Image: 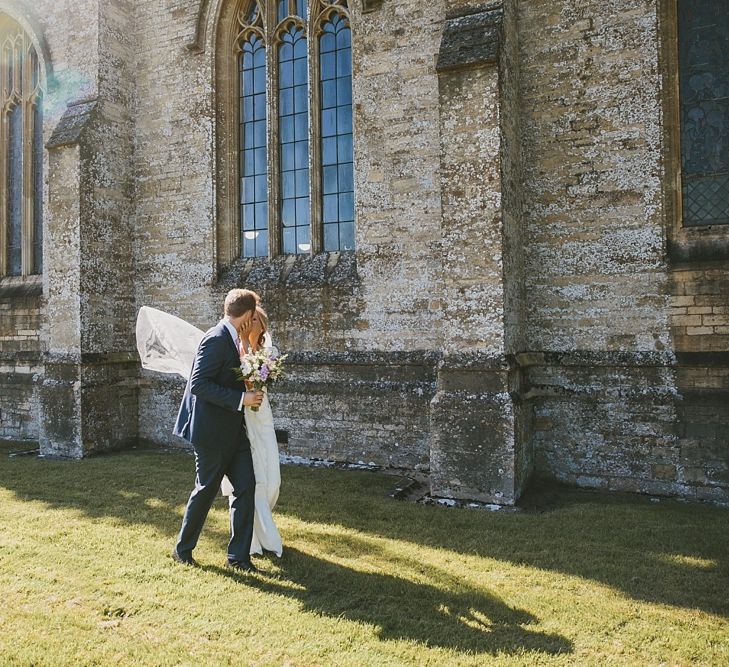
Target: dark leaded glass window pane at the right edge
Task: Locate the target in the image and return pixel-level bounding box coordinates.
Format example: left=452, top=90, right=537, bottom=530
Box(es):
left=677, top=0, right=729, bottom=226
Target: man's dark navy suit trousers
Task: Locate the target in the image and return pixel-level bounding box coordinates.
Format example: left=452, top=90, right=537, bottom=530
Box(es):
left=176, top=433, right=256, bottom=561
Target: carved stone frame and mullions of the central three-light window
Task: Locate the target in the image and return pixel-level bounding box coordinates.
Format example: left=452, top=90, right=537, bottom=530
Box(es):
left=214, top=0, right=354, bottom=269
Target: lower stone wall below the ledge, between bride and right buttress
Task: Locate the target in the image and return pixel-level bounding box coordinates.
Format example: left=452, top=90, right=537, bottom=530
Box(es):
left=271, top=352, right=437, bottom=470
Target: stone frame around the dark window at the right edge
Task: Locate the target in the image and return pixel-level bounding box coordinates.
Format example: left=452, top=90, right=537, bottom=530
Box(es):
left=658, top=0, right=729, bottom=262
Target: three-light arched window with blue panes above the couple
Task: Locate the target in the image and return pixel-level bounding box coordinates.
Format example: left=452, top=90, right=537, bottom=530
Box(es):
left=234, top=0, right=354, bottom=257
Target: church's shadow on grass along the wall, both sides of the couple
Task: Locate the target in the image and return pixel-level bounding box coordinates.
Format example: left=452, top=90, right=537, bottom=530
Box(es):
left=0, top=448, right=729, bottom=624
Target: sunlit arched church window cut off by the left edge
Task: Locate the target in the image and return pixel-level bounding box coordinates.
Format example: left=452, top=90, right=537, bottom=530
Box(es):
left=0, top=14, right=43, bottom=276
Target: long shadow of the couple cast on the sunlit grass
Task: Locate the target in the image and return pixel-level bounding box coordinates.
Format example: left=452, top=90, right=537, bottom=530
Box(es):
left=204, top=543, right=572, bottom=655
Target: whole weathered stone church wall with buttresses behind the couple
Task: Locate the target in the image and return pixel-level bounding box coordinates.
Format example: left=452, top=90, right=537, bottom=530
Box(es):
left=0, top=0, right=729, bottom=502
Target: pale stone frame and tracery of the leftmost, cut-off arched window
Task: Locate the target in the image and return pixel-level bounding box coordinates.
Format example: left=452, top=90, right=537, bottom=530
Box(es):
left=0, top=12, right=47, bottom=284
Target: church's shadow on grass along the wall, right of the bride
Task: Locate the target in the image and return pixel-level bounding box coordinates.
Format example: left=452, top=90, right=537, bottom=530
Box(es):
left=277, top=470, right=729, bottom=617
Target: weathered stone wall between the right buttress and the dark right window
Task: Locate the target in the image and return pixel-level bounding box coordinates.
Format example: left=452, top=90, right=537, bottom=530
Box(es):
left=519, top=0, right=676, bottom=492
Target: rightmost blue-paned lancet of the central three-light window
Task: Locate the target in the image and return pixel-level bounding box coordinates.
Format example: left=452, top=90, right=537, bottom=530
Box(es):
left=319, top=14, right=354, bottom=250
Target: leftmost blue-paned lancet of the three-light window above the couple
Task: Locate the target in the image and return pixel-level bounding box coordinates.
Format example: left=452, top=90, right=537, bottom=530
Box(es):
left=239, top=34, right=268, bottom=257
